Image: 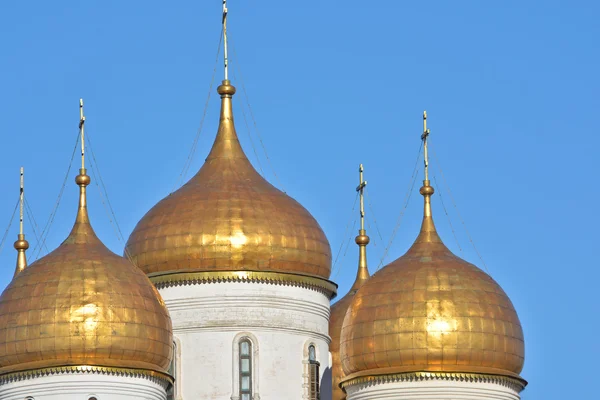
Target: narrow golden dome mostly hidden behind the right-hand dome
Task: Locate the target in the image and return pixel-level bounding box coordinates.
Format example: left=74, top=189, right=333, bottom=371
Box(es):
left=329, top=229, right=369, bottom=400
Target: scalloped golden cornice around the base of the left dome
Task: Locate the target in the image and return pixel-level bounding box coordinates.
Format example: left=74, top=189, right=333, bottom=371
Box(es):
left=0, top=365, right=173, bottom=389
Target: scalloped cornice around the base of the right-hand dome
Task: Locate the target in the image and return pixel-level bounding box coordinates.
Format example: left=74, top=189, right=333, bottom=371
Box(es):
left=340, top=372, right=527, bottom=393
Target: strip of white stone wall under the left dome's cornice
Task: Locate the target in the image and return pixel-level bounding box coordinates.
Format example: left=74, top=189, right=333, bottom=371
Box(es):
left=0, top=372, right=167, bottom=400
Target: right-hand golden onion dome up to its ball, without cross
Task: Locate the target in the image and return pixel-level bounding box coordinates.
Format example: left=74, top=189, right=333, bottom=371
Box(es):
left=341, top=180, right=525, bottom=379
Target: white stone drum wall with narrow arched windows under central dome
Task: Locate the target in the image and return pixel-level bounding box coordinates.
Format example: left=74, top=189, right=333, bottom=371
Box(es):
left=159, top=282, right=331, bottom=400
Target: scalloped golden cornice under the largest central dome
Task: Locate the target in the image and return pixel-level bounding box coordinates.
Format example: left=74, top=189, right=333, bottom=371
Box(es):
left=148, top=271, right=337, bottom=299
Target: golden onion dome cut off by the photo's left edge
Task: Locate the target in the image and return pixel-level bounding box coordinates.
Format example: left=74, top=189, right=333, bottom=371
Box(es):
left=0, top=169, right=172, bottom=374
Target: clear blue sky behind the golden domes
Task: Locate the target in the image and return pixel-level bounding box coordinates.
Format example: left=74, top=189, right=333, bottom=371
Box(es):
left=0, top=0, right=600, bottom=400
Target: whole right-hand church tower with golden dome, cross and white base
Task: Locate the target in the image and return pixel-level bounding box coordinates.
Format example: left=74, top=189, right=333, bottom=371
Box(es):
left=340, top=114, right=527, bottom=400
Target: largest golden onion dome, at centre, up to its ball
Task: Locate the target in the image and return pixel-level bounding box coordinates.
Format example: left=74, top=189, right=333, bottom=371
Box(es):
left=125, top=80, right=331, bottom=279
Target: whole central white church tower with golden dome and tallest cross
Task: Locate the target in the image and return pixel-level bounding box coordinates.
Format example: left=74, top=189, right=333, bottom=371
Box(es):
left=125, top=1, right=336, bottom=400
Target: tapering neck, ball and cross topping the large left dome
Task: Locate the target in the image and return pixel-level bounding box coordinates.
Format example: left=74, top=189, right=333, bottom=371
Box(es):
left=65, top=99, right=98, bottom=243
